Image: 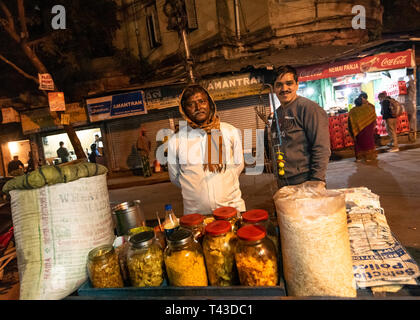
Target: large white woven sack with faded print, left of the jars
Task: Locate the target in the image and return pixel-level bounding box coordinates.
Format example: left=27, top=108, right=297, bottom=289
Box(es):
left=10, top=175, right=115, bottom=300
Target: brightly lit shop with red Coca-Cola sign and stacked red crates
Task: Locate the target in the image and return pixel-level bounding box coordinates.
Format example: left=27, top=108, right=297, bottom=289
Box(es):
left=298, top=49, right=416, bottom=150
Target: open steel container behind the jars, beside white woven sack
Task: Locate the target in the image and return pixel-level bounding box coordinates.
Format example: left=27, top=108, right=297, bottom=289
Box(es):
left=112, top=200, right=146, bottom=236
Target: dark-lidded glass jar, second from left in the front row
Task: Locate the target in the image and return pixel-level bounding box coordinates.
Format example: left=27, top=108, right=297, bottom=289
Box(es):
left=127, top=231, right=164, bottom=287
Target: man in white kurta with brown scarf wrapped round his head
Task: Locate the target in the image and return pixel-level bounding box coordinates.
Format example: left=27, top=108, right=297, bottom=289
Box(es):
left=168, top=85, right=245, bottom=214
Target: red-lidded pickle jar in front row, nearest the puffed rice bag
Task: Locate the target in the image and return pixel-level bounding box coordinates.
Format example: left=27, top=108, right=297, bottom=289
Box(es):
left=235, top=225, right=278, bottom=286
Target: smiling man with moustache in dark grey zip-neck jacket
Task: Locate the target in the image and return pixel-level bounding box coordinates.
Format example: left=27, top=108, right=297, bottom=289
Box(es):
left=272, top=66, right=331, bottom=188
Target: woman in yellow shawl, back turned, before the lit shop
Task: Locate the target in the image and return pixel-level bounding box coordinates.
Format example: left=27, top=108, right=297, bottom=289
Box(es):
left=348, top=97, right=376, bottom=162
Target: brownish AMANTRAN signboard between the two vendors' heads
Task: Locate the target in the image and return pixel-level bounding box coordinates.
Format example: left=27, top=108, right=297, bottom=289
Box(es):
left=200, top=73, right=268, bottom=100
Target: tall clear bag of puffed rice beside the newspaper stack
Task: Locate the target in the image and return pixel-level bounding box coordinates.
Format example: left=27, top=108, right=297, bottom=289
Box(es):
left=274, top=182, right=356, bottom=297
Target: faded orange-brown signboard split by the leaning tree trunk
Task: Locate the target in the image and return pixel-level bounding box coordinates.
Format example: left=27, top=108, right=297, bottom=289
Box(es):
left=21, top=103, right=88, bottom=134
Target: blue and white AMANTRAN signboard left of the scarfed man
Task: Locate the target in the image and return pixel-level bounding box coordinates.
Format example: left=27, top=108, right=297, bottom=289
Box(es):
left=86, top=91, right=147, bottom=122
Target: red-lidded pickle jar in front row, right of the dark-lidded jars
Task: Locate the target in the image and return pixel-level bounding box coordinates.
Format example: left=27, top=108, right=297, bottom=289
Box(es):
left=203, top=220, right=238, bottom=286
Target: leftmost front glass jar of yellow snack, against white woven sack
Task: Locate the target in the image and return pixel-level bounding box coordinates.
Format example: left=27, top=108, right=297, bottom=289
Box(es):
left=87, top=245, right=124, bottom=288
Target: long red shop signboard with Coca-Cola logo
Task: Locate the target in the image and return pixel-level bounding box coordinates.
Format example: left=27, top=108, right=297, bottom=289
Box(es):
left=297, top=50, right=415, bottom=82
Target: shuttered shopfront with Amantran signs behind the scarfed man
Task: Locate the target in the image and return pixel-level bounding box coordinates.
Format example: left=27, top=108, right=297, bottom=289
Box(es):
left=86, top=74, right=270, bottom=172
